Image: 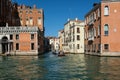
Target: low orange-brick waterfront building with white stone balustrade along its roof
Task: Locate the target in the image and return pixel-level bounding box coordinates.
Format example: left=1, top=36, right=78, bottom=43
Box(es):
left=0, top=27, right=40, bottom=55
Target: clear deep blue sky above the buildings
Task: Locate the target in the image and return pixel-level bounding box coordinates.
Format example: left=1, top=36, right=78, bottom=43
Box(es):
left=12, top=0, right=101, bottom=37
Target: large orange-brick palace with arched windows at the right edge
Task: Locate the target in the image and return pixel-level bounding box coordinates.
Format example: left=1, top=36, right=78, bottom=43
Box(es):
left=85, top=0, right=120, bottom=56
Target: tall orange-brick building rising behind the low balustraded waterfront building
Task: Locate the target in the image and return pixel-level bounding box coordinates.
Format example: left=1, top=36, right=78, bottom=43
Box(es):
left=18, top=5, right=44, bottom=35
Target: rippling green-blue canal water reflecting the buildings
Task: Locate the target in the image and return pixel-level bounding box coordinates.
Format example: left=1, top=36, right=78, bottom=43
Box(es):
left=0, top=52, right=120, bottom=80
